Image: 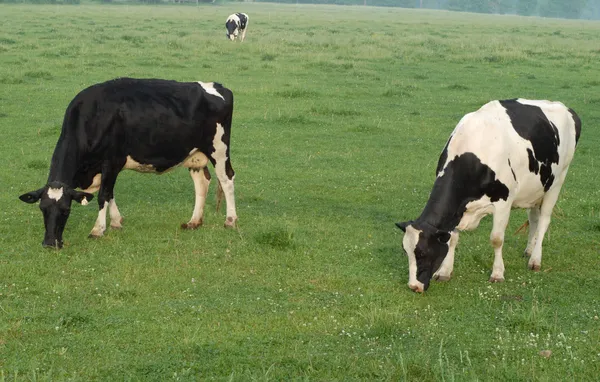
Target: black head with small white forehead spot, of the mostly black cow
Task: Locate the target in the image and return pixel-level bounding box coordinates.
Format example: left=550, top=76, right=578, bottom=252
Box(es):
left=19, top=182, right=94, bottom=249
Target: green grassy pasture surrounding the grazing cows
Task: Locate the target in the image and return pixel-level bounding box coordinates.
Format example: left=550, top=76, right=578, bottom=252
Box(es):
left=0, top=4, right=600, bottom=381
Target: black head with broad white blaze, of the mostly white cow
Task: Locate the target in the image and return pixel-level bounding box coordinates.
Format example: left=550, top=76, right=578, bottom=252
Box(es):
left=396, top=221, right=451, bottom=292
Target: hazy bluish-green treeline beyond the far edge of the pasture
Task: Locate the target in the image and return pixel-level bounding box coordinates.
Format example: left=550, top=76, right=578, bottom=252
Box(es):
left=0, top=0, right=600, bottom=19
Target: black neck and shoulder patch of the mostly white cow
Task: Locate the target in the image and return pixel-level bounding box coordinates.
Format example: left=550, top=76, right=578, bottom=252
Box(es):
left=416, top=152, right=509, bottom=232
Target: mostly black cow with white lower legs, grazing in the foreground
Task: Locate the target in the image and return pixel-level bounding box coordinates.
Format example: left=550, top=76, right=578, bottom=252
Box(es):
left=20, top=78, right=237, bottom=248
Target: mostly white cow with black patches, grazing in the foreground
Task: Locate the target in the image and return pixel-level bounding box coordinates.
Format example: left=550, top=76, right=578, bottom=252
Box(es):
left=396, top=99, right=581, bottom=292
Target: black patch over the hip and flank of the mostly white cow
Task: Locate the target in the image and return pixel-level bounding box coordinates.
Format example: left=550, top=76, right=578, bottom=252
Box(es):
left=499, top=100, right=560, bottom=191
